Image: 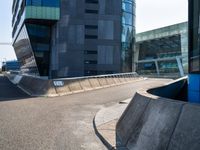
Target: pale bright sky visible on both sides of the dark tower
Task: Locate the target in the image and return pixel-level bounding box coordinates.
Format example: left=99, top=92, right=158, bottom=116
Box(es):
left=0, top=0, right=188, bottom=65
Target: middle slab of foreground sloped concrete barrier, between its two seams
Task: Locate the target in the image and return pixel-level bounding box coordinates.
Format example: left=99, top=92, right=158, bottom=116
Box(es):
left=126, top=99, right=182, bottom=150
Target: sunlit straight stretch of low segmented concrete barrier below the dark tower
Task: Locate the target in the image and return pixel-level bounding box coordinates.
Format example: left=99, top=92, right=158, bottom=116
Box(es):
left=53, top=73, right=143, bottom=95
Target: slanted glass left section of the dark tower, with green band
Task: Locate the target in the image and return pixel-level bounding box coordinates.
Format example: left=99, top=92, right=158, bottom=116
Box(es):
left=13, top=0, right=60, bottom=76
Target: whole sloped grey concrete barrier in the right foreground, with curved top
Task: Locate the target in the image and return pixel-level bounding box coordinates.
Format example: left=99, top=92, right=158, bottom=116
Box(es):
left=116, top=77, right=200, bottom=150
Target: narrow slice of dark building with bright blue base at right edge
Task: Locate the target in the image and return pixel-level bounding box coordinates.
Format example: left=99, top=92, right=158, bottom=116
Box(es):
left=188, top=0, right=200, bottom=103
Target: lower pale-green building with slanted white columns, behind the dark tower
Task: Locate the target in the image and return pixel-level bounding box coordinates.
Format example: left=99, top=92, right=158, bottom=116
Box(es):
left=133, top=22, right=188, bottom=76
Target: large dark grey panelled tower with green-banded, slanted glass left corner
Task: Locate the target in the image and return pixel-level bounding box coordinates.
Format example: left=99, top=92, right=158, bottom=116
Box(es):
left=12, top=0, right=135, bottom=78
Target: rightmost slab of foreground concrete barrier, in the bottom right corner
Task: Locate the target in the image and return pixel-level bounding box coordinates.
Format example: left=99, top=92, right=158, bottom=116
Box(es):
left=169, top=104, right=200, bottom=150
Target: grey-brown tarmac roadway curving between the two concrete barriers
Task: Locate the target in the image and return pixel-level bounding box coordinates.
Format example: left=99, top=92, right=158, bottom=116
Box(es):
left=0, top=76, right=172, bottom=150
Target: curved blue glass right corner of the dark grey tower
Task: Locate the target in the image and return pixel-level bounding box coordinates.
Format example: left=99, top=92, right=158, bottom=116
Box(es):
left=121, top=0, right=135, bottom=72
